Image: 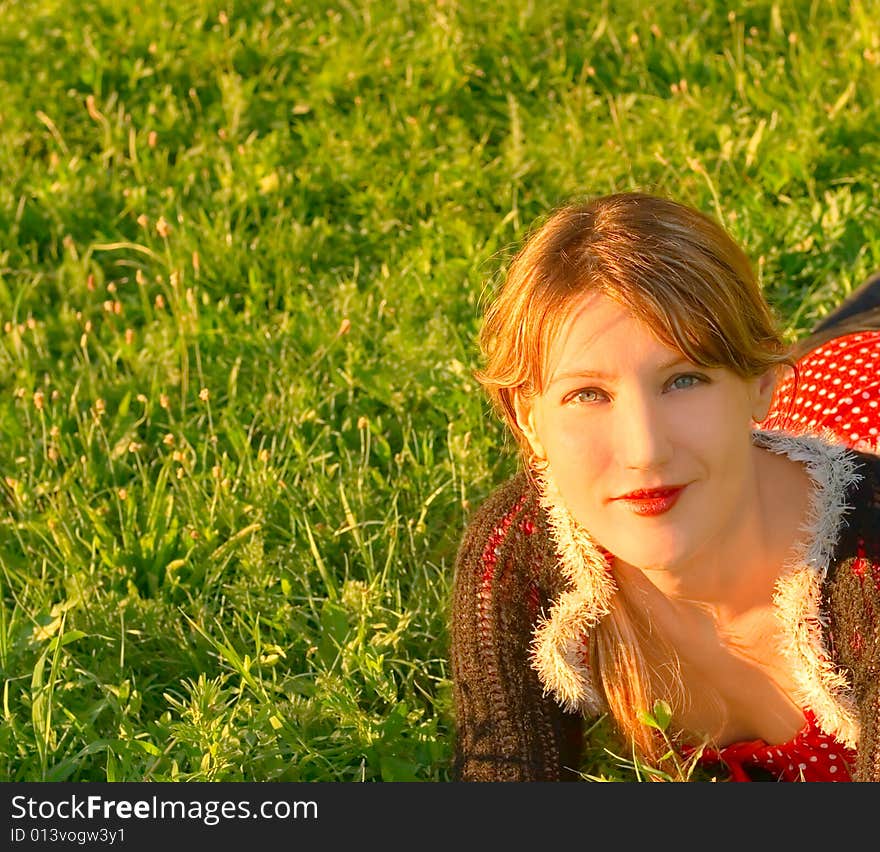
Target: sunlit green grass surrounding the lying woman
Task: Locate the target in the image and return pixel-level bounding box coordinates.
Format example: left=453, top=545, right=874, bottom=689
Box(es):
left=0, top=0, right=880, bottom=781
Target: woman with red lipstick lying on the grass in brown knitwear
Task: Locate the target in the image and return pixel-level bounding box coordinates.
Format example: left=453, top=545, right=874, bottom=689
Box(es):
left=452, top=193, right=880, bottom=781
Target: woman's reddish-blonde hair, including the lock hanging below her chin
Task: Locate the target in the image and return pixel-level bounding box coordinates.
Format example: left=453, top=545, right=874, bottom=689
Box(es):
left=476, top=192, right=792, bottom=759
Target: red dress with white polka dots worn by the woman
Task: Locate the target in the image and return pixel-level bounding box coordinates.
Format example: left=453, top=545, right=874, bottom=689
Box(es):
left=701, top=331, right=880, bottom=781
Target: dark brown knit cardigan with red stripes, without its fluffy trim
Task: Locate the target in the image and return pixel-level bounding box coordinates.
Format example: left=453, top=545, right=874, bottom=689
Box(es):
left=451, top=440, right=880, bottom=781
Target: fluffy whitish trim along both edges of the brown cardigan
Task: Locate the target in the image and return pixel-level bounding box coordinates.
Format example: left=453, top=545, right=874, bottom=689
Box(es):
left=531, top=430, right=860, bottom=747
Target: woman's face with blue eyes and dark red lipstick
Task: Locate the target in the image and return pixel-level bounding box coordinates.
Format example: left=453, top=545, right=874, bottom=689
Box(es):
left=516, top=293, right=773, bottom=568
